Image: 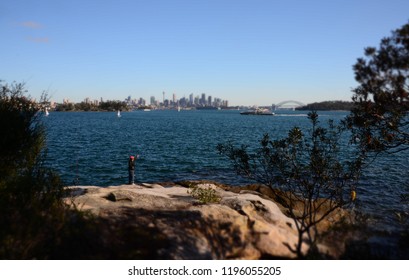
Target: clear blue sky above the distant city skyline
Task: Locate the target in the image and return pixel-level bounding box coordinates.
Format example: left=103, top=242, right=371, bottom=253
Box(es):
left=0, top=0, right=409, bottom=105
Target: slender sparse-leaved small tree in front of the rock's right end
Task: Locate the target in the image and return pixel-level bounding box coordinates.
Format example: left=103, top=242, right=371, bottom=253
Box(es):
left=217, top=112, right=363, bottom=258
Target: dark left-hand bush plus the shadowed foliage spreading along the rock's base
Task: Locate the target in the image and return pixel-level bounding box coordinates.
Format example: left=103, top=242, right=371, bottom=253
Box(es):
left=0, top=84, right=167, bottom=259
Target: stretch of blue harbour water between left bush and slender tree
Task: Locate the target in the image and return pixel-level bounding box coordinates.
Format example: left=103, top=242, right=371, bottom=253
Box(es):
left=46, top=110, right=307, bottom=186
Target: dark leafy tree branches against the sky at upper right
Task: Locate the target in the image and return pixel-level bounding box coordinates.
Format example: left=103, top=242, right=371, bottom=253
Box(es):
left=347, top=21, right=409, bottom=152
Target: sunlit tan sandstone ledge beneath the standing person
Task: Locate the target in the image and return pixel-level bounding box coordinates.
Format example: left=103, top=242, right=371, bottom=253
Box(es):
left=66, top=183, right=338, bottom=259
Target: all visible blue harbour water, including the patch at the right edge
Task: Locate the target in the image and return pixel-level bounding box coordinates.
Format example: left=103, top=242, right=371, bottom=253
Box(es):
left=44, top=110, right=409, bottom=233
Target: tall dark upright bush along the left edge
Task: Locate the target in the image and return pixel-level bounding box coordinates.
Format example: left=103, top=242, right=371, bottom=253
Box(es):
left=0, top=83, right=64, bottom=259
